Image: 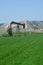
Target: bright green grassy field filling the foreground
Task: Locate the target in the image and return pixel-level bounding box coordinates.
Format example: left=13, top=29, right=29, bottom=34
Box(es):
left=0, top=34, right=43, bottom=65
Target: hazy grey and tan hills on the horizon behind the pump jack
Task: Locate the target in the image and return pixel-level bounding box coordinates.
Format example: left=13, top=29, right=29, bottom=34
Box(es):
left=0, top=20, right=43, bottom=32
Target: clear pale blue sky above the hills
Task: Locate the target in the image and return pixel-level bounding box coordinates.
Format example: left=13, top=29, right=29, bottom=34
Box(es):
left=0, top=0, right=43, bottom=22
